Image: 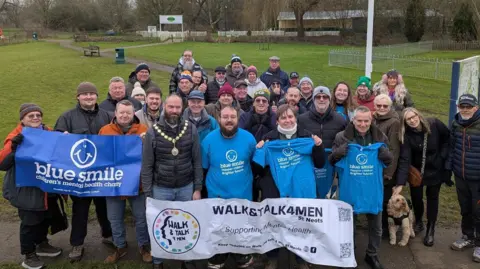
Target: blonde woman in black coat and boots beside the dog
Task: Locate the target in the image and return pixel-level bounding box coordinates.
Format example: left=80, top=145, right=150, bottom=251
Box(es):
left=394, top=107, right=453, bottom=247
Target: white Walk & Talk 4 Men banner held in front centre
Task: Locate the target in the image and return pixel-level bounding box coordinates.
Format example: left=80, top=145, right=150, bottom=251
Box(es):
left=147, top=198, right=357, bottom=267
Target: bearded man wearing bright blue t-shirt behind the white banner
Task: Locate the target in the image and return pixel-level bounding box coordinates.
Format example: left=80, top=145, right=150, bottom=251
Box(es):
left=202, top=106, right=256, bottom=269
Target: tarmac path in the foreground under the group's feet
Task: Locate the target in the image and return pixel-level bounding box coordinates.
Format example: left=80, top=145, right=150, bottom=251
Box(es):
left=0, top=222, right=480, bottom=269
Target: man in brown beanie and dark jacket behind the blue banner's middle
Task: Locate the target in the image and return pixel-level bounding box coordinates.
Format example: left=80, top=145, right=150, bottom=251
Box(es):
left=54, top=82, right=113, bottom=261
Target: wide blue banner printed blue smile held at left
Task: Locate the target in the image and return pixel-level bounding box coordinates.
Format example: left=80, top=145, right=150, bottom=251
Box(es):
left=15, top=128, right=142, bottom=197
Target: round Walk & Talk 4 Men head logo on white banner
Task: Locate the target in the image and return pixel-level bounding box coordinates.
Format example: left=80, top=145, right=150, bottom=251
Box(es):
left=153, top=209, right=200, bottom=254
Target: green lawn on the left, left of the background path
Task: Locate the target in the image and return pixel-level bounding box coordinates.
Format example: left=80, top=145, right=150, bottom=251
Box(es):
left=0, top=42, right=170, bottom=221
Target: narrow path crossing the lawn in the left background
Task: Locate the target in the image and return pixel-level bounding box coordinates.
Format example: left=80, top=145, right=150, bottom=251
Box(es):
left=45, top=39, right=213, bottom=81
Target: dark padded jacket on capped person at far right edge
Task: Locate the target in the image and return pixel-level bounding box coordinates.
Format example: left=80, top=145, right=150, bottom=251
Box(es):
left=446, top=110, right=480, bottom=181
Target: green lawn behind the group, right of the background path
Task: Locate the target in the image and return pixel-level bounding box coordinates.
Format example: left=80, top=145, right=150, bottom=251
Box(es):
left=126, top=42, right=450, bottom=121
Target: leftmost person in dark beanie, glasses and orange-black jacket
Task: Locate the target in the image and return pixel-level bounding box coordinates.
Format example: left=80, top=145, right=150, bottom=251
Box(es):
left=0, top=103, right=62, bottom=269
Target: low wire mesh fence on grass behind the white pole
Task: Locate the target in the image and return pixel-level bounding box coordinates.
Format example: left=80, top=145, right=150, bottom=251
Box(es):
left=328, top=50, right=452, bottom=81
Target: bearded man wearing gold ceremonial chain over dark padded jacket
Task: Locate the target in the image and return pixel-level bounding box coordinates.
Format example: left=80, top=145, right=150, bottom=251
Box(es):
left=141, top=94, right=203, bottom=269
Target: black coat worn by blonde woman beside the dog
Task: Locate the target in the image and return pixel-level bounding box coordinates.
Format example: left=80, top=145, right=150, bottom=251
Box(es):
left=397, top=118, right=451, bottom=186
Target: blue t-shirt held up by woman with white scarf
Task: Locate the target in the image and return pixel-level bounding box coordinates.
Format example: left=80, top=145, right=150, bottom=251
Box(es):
left=253, top=138, right=317, bottom=198
